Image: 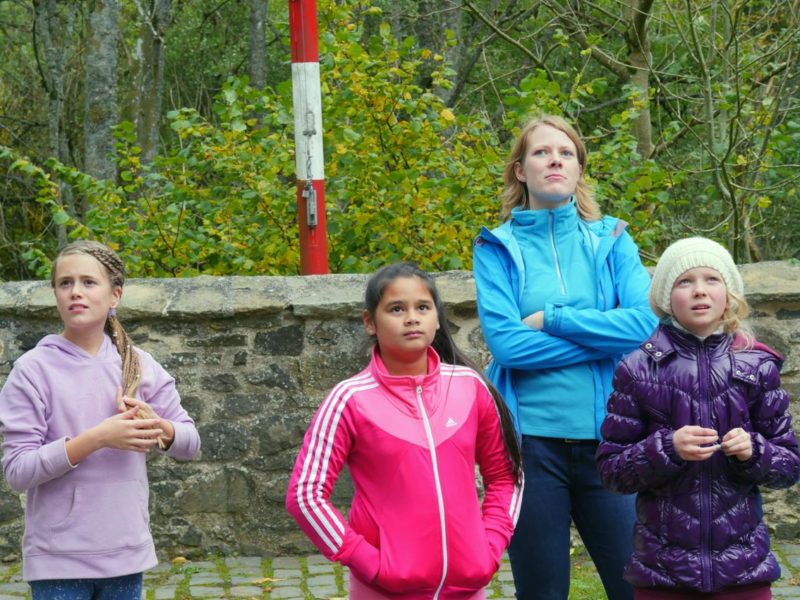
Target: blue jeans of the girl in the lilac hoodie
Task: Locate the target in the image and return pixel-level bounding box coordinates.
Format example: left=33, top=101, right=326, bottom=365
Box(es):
left=30, top=573, right=142, bottom=600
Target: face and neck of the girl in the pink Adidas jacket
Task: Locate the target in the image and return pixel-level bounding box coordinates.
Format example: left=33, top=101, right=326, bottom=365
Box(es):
left=364, top=277, right=439, bottom=375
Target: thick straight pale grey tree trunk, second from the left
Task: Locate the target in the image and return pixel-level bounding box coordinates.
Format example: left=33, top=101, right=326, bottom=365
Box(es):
left=83, top=0, right=119, bottom=190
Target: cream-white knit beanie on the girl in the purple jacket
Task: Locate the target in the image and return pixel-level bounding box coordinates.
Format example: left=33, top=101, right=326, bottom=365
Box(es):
left=649, top=237, right=744, bottom=317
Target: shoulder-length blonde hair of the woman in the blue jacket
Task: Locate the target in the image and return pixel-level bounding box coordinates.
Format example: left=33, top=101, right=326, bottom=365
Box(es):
left=501, top=115, right=603, bottom=221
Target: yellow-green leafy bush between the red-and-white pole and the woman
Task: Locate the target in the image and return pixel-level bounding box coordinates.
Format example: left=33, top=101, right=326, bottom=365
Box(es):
left=322, top=3, right=502, bottom=272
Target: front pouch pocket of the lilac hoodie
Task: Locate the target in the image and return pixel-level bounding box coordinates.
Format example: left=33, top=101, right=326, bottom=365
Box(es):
left=48, top=480, right=150, bottom=553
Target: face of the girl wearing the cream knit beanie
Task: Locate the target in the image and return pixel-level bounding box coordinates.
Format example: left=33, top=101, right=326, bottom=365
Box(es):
left=670, top=267, right=728, bottom=337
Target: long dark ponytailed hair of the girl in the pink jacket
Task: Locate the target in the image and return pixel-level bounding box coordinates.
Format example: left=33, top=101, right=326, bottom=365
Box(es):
left=364, top=262, right=522, bottom=481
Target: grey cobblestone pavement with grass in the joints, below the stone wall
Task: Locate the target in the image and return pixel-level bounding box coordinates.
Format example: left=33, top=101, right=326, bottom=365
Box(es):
left=0, top=543, right=800, bottom=600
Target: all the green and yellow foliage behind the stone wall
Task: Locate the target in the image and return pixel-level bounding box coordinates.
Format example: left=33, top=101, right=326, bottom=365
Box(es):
left=10, top=0, right=800, bottom=278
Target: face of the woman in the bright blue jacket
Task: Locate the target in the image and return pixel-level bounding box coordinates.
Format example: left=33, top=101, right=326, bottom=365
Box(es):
left=514, top=125, right=583, bottom=210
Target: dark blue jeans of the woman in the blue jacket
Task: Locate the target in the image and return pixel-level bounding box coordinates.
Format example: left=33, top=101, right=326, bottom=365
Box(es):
left=508, top=436, right=636, bottom=600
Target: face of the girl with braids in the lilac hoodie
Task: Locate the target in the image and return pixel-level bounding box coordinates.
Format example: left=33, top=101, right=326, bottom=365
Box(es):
left=54, top=254, right=122, bottom=345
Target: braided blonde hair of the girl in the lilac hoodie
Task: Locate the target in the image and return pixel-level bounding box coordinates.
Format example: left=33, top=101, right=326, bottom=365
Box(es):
left=50, top=240, right=142, bottom=398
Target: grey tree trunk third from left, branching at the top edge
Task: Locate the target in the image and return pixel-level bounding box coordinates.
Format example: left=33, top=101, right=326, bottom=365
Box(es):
left=136, top=0, right=171, bottom=164
